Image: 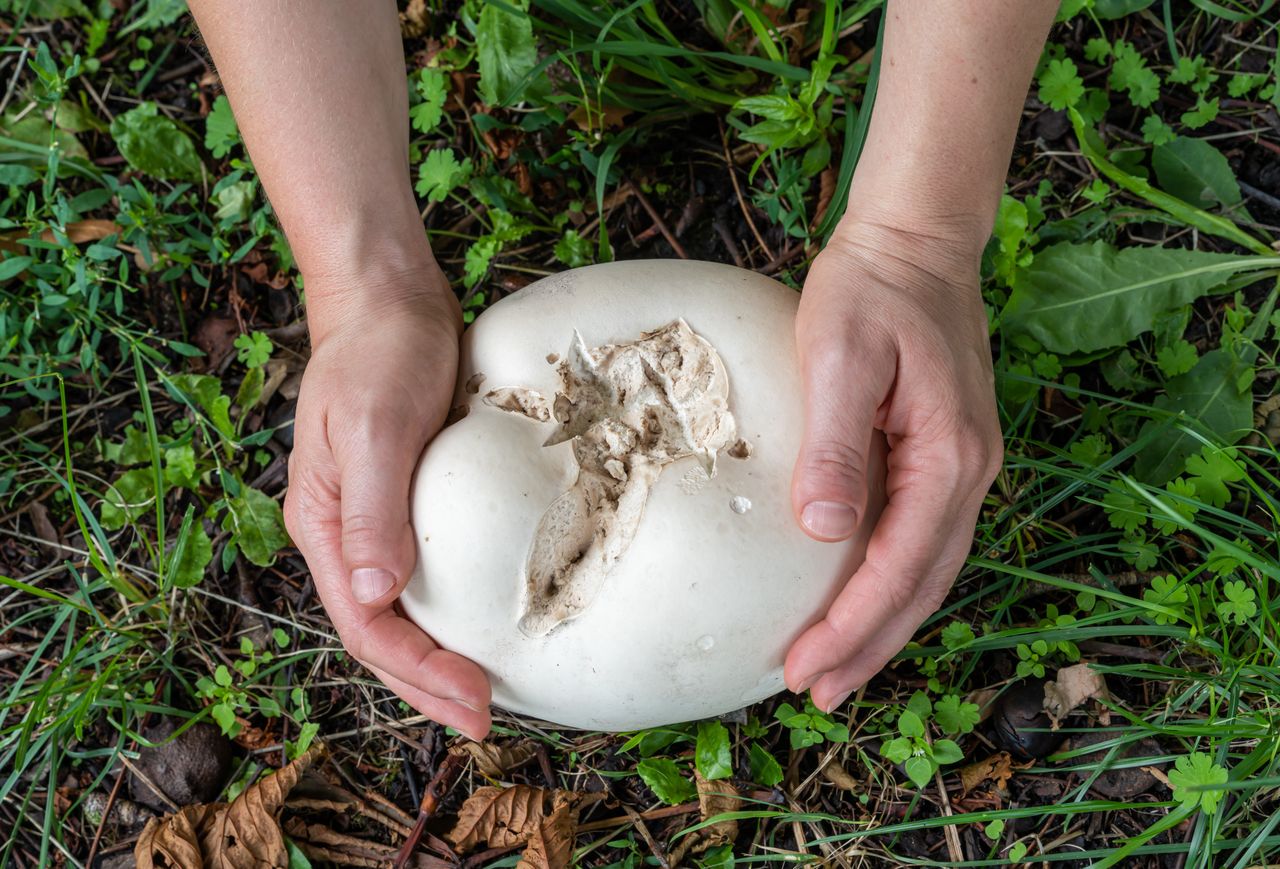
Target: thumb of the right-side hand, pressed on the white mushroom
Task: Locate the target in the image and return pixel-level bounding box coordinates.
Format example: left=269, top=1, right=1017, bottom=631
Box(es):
left=791, top=346, right=893, bottom=541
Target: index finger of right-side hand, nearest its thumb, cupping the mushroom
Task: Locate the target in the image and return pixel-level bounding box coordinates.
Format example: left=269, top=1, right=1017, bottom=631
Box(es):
left=785, top=438, right=987, bottom=691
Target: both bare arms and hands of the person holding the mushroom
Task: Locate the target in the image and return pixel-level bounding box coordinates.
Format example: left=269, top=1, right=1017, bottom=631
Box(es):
left=189, top=0, right=1057, bottom=738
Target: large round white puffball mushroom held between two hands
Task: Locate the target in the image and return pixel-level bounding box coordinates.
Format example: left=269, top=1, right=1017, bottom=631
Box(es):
left=401, top=260, right=884, bottom=731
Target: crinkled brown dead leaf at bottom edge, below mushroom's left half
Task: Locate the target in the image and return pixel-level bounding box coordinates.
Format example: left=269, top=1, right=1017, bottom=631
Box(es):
left=444, top=785, right=577, bottom=869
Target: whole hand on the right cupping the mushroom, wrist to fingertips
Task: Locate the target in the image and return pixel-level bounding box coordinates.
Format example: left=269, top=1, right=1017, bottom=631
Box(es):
left=786, top=215, right=1002, bottom=710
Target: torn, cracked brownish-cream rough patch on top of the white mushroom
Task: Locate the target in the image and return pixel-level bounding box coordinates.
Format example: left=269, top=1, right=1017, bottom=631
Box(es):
left=485, top=320, right=736, bottom=636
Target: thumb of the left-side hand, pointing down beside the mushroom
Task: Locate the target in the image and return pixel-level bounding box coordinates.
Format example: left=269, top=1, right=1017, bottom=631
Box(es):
left=339, top=426, right=417, bottom=607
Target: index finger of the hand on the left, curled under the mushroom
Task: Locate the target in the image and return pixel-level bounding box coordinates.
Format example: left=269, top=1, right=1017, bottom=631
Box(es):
left=287, top=452, right=490, bottom=710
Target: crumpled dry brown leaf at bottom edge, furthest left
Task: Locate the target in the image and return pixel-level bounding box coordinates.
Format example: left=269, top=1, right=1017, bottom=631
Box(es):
left=133, top=744, right=325, bottom=869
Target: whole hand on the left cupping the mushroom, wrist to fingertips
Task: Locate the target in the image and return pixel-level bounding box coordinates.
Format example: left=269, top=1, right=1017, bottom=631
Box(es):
left=284, top=264, right=490, bottom=740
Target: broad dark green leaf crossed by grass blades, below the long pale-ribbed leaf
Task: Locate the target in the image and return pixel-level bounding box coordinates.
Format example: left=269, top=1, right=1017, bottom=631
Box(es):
left=1133, top=349, right=1253, bottom=485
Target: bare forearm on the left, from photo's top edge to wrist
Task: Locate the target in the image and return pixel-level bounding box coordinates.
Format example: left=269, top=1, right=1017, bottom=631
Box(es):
left=191, top=0, right=443, bottom=337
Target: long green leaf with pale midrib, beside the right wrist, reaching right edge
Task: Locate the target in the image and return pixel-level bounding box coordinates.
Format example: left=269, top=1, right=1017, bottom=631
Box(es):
left=1001, top=241, right=1280, bottom=353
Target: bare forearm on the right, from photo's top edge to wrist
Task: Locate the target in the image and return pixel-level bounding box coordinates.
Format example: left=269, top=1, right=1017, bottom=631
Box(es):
left=850, top=0, right=1057, bottom=250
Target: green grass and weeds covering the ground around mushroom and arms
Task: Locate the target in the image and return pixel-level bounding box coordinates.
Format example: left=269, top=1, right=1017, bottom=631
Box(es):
left=0, top=0, right=1280, bottom=869
